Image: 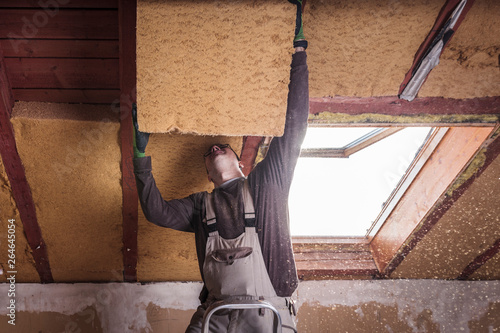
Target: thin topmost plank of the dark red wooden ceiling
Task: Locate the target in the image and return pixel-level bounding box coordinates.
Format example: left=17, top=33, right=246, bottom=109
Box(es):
left=0, top=0, right=118, bottom=9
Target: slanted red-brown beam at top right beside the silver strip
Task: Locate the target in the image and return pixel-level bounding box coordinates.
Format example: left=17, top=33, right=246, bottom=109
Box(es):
left=398, top=0, right=474, bottom=94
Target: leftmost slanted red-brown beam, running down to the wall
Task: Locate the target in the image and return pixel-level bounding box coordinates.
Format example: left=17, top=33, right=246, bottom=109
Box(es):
left=0, top=50, right=54, bottom=283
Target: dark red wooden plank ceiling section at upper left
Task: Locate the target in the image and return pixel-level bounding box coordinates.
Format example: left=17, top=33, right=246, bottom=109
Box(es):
left=0, top=0, right=120, bottom=104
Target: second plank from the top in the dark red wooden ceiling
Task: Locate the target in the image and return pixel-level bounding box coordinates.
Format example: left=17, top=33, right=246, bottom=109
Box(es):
left=0, top=9, right=118, bottom=40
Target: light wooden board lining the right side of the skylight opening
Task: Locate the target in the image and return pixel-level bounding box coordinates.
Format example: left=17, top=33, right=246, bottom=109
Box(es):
left=370, top=127, right=492, bottom=276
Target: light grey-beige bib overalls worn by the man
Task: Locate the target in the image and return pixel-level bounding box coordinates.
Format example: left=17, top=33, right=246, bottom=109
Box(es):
left=186, top=180, right=295, bottom=333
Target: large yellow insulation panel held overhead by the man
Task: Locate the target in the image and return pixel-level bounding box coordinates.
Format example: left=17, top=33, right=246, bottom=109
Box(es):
left=137, top=0, right=296, bottom=136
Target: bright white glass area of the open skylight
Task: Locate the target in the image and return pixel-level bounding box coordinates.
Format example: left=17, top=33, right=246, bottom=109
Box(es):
left=289, top=127, right=431, bottom=237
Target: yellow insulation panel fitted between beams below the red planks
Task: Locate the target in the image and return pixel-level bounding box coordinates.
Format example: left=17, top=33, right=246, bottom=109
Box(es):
left=12, top=103, right=123, bottom=282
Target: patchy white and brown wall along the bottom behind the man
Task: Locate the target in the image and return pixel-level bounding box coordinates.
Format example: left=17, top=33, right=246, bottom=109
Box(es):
left=0, top=280, right=500, bottom=333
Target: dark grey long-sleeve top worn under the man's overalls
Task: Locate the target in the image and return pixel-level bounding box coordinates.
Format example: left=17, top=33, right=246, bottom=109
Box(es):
left=134, top=52, right=309, bottom=302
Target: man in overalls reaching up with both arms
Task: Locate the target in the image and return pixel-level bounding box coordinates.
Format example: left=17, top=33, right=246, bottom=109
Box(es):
left=134, top=0, right=309, bottom=333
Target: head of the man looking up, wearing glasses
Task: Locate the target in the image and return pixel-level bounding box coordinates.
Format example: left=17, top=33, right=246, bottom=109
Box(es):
left=203, top=144, right=243, bottom=187
